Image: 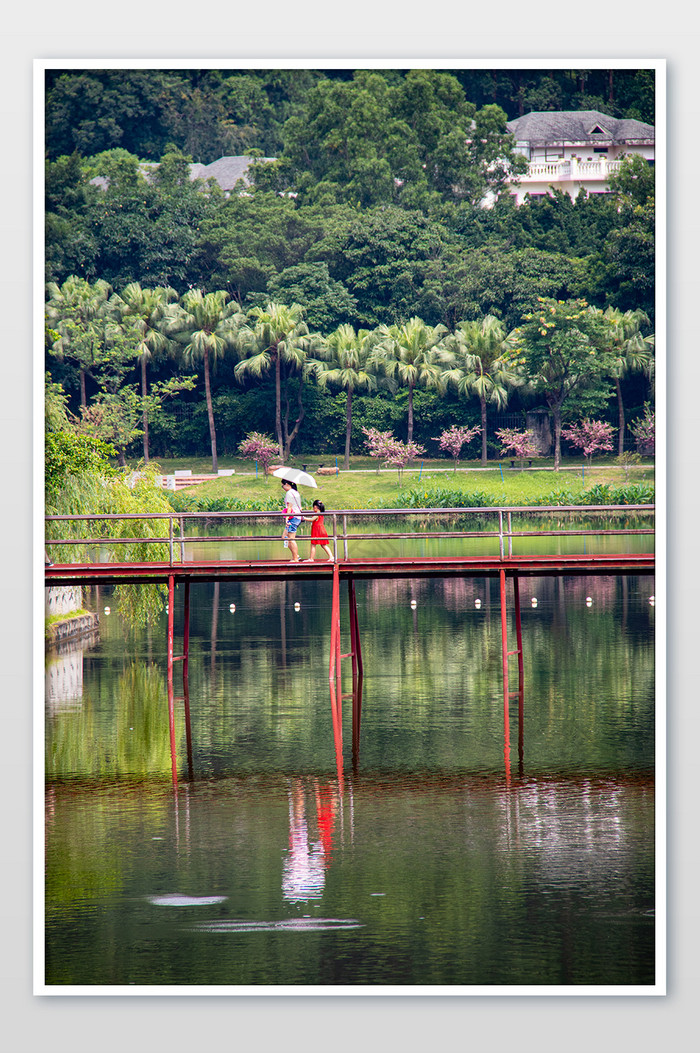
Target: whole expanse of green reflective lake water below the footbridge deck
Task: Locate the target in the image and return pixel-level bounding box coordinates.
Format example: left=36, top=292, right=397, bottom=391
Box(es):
left=45, top=576, right=657, bottom=993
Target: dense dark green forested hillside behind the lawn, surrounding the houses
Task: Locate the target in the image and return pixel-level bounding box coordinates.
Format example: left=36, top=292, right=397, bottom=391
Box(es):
left=45, top=68, right=655, bottom=457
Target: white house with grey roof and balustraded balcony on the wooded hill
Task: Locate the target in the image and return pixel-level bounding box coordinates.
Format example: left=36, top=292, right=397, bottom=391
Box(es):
left=507, top=110, right=654, bottom=204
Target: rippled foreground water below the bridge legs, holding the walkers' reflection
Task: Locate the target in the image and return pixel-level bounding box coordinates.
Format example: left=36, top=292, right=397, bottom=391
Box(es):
left=47, top=774, right=654, bottom=992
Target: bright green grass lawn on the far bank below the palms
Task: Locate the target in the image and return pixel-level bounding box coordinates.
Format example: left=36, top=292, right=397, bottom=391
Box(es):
left=142, top=455, right=654, bottom=511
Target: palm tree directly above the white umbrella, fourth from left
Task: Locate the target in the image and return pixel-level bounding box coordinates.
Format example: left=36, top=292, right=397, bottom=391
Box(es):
left=235, top=303, right=319, bottom=461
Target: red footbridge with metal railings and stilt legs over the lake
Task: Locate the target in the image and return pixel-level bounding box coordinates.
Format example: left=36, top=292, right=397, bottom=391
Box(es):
left=45, top=505, right=655, bottom=792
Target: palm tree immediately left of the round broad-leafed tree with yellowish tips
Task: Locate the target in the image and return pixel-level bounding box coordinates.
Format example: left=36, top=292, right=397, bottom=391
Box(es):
left=445, top=315, right=520, bottom=464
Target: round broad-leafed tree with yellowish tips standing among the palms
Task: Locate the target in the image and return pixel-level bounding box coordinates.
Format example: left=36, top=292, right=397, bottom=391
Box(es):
left=507, top=297, right=611, bottom=471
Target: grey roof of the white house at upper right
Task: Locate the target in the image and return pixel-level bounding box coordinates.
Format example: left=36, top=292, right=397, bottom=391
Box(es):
left=506, top=110, right=654, bottom=144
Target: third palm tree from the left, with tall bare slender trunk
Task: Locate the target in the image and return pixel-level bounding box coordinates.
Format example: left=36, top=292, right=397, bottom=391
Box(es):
left=163, top=289, right=244, bottom=472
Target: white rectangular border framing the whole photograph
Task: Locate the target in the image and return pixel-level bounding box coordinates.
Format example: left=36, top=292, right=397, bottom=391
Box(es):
left=33, top=56, right=667, bottom=997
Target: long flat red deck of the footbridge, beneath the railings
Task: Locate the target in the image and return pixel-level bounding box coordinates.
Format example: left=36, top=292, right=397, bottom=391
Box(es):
left=45, top=553, right=656, bottom=587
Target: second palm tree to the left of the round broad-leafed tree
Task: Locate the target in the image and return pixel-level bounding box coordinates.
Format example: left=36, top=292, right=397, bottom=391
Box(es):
left=367, top=317, right=454, bottom=442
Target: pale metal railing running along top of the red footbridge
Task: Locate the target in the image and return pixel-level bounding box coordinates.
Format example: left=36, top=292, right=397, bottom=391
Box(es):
left=45, top=504, right=655, bottom=565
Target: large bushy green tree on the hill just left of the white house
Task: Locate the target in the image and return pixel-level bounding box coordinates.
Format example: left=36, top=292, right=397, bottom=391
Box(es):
left=267, top=69, right=525, bottom=212
